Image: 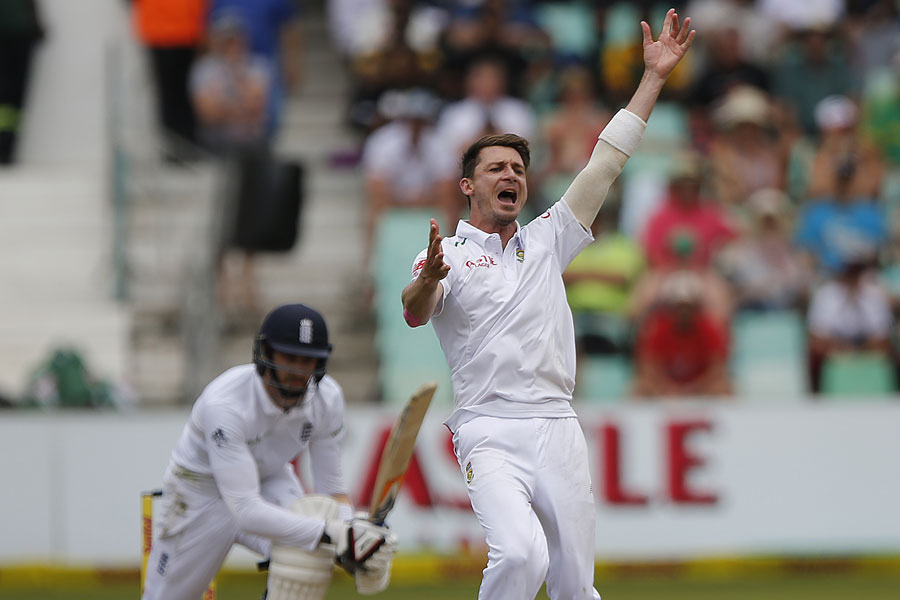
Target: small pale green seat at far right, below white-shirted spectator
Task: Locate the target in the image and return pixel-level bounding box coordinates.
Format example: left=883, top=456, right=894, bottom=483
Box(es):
left=822, top=353, right=896, bottom=399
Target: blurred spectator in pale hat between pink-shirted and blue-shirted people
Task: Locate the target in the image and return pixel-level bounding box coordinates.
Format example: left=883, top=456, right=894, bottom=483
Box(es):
left=717, top=189, right=812, bottom=310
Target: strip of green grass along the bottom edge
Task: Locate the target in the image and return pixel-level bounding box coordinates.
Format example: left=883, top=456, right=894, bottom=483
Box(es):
left=0, top=573, right=900, bottom=600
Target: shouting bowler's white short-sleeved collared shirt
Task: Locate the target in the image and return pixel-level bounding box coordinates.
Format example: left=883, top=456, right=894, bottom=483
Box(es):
left=412, top=201, right=593, bottom=432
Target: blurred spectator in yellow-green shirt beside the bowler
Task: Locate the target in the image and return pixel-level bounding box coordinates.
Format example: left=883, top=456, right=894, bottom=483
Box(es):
left=563, top=198, right=644, bottom=357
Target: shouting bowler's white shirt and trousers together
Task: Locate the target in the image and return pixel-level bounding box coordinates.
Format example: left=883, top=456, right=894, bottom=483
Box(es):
left=413, top=201, right=600, bottom=600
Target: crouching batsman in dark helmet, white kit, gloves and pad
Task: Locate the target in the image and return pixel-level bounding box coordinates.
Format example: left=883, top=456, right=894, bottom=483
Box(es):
left=142, top=304, right=397, bottom=600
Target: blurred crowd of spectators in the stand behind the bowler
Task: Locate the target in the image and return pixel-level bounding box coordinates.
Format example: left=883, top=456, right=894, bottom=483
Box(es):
left=342, top=0, right=900, bottom=397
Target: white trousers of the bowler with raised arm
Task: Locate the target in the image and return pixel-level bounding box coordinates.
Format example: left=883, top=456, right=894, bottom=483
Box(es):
left=453, top=416, right=600, bottom=600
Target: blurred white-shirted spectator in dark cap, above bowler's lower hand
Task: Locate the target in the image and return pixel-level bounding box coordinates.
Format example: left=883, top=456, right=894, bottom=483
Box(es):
left=363, top=89, right=451, bottom=251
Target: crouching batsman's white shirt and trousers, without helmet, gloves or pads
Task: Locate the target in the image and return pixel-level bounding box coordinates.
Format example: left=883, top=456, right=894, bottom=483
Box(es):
left=143, top=364, right=347, bottom=600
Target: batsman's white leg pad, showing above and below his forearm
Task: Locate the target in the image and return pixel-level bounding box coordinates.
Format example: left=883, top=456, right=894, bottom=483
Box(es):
left=266, top=494, right=339, bottom=600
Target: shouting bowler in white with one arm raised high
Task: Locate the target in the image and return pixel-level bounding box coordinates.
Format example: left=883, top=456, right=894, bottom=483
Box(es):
left=402, top=9, right=695, bottom=600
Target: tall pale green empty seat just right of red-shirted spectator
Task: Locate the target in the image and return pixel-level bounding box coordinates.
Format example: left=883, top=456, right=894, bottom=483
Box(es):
left=732, top=311, right=806, bottom=402
